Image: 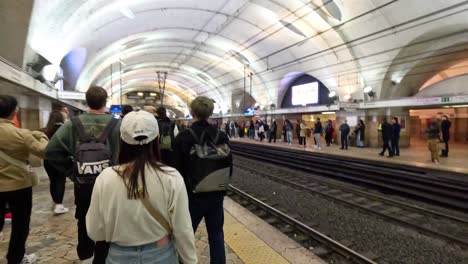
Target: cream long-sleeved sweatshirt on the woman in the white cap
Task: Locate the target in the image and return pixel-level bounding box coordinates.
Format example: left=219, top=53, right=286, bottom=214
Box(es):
left=86, top=167, right=197, bottom=264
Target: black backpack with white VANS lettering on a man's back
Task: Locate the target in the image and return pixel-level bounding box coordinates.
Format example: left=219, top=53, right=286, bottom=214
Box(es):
left=71, top=117, right=118, bottom=184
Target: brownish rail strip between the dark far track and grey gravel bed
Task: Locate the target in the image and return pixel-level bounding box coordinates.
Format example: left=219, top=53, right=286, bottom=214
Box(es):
left=234, top=156, right=468, bottom=248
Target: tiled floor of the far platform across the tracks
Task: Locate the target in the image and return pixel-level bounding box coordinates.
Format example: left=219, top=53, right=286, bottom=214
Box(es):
left=231, top=138, right=468, bottom=176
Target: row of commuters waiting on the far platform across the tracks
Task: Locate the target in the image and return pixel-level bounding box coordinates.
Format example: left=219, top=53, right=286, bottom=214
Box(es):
left=238, top=115, right=451, bottom=163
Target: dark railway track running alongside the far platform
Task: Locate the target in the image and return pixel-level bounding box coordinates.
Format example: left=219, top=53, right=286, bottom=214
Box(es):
left=231, top=142, right=468, bottom=213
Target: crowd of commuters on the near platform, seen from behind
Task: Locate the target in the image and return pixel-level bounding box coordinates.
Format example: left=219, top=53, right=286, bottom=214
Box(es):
left=0, top=87, right=232, bottom=264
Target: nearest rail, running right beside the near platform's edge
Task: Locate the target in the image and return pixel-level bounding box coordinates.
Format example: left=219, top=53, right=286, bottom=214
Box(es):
left=228, top=185, right=376, bottom=264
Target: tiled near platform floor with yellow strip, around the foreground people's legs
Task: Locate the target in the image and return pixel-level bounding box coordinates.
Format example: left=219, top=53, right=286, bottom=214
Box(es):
left=0, top=168, right=322, bottom=264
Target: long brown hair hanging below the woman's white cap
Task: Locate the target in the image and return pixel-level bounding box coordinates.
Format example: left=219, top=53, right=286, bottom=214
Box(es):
left=115, top=138, right=163, bottom=199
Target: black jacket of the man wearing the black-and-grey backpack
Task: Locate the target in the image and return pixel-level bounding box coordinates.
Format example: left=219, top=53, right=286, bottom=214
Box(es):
left=174, top=121, right=232, bottom=196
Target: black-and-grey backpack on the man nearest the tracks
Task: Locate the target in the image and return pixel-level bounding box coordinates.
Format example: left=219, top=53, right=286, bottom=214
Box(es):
left=188, top=128, right=232, bottom=193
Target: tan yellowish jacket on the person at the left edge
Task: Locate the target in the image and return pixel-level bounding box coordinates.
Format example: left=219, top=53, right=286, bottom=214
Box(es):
left=0, top=118, right=48, bottom=192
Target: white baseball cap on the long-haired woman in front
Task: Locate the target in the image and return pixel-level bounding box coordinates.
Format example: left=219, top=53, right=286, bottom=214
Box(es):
left=120, top=111, right=159, bottom=145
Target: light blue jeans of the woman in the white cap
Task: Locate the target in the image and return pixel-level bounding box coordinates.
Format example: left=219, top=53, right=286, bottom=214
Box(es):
left=106, top=241, right=179, bottom=264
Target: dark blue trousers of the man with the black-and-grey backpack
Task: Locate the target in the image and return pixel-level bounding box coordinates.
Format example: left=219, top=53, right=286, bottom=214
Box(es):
left=189, top=192, right=226, bottom=264
